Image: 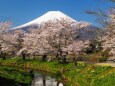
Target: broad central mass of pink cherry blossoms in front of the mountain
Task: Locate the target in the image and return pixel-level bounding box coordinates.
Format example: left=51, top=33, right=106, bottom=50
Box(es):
left=23, top=19, right=95, bottom=62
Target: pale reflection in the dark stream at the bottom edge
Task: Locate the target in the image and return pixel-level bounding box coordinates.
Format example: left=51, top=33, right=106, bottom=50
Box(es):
left=32, top=73, right=63, bottom=86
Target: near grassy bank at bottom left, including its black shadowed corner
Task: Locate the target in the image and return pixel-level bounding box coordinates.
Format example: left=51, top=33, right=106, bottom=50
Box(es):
left=0, top=66, right=33, bottom=86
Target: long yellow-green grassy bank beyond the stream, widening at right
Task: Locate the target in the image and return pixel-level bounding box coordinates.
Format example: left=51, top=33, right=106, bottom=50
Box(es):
left=0, top=59, right=115, bottom=86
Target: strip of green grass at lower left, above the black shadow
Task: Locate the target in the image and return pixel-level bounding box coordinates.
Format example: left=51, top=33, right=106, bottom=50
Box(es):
left=0, top=66, right=32, bottom=86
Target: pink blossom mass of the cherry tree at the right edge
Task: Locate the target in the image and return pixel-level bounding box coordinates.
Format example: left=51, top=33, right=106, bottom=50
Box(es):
left=103, top=9, right=115, bottom=59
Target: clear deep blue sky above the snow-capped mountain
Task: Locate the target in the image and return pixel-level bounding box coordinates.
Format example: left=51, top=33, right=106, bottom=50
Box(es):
left=0, top=0, right=113, bottom=27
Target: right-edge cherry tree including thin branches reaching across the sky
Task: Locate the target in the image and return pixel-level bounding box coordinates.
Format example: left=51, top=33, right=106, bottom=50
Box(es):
left=86, top=0, right=115, bottom=59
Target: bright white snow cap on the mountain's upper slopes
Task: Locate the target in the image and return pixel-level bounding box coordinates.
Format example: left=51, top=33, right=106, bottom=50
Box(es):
left=13, top=11, right=77, bottom=29
